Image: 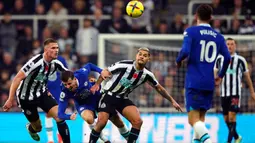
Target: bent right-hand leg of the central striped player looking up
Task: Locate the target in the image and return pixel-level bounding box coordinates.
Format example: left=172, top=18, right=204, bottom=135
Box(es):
left=117, top=99, right=143, bottom=143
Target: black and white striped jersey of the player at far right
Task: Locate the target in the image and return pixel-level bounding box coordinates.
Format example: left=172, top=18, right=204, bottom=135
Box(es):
left=214, top=53, right=248, bottom=97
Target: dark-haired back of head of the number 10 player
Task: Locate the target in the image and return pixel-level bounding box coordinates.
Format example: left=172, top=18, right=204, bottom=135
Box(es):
left=196, top=4, right=213, bottom=23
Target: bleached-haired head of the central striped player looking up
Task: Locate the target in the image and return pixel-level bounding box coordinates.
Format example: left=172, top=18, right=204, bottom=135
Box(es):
left=136, top=47, right=150, bottom=66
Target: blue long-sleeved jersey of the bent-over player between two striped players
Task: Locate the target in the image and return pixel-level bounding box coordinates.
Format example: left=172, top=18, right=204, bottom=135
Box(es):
left=58, top=63, right=102, bottom=120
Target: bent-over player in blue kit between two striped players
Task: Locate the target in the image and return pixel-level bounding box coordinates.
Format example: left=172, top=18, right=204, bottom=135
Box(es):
left=58, top=63, right=129, bottom=143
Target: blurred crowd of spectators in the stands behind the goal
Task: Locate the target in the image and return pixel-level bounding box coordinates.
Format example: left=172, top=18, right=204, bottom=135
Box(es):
left=0, top=0, right=255, bottom=112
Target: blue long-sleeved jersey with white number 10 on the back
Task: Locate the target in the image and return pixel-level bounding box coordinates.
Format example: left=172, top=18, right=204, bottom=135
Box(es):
left=176, top=24, right=231, bottom=90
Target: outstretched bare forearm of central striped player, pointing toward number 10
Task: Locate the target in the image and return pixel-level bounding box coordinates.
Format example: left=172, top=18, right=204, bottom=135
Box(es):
left=154, top=84, right=183, bottom=112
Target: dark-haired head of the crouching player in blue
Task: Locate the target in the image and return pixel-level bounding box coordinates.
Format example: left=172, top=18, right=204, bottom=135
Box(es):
left=60, top=71, right=78, bottom=91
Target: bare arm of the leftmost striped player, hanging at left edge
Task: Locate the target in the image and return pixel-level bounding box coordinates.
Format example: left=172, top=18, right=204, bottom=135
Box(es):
left=3, top=70, right=26, bottom=112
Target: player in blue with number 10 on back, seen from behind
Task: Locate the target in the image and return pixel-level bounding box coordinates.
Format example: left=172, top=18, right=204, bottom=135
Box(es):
left=176, top=4, right=231, bottom=143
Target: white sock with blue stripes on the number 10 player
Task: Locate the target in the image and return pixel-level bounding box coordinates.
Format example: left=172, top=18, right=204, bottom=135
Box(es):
left=193, top=121, right=212, bottom=143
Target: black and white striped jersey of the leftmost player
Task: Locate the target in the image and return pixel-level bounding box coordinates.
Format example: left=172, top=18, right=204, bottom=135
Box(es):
left=16, top=54, right=67, bottom=101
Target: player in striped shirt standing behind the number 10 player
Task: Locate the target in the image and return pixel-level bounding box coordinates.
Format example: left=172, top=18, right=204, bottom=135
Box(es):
left=214, top=38, right=255, bottom=143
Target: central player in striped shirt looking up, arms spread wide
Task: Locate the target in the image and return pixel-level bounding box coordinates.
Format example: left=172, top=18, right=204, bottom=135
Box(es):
left=89, top=48, right=182, bottom=143
